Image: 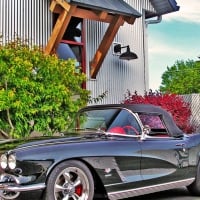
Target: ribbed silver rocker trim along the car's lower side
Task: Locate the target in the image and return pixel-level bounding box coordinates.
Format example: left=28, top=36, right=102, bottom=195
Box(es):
left=108, top=178, right=195, bottom=200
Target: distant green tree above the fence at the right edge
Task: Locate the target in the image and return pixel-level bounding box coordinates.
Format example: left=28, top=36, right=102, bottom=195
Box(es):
left=160, top=60, right=200, bottom=94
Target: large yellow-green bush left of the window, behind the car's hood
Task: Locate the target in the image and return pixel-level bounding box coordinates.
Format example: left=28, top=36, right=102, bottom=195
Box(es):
left=0, top=39, right=89, bottom=138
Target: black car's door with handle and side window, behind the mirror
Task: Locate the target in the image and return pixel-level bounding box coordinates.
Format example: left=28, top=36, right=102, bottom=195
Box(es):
left=138, top=115, right=189, bottom=186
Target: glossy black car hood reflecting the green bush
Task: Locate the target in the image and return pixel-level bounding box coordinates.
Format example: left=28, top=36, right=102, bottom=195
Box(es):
left=0, top=133, right=102, bottom=154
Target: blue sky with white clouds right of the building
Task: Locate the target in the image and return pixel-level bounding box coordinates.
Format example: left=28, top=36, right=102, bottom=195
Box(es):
left=148, top=0, right=200, bottom=90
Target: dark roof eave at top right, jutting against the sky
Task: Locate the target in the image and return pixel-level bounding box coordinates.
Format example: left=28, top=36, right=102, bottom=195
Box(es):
left=145, top=0, right=180, bottom=19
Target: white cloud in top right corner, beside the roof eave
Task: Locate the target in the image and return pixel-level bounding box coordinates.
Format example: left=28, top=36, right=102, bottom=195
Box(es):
left=163, top=0, right=200, bottom=24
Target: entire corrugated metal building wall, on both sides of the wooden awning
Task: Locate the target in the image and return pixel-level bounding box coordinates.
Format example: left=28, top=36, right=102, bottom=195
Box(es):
left=0, top=0, right=153, bottom=103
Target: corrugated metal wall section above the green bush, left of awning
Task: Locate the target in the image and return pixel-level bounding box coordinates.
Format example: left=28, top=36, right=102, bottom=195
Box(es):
left=0, top=0, right=53, bottom=46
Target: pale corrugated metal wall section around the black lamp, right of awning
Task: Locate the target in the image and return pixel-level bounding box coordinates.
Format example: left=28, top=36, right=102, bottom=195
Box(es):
left=86, top=0, right=153, bottom=103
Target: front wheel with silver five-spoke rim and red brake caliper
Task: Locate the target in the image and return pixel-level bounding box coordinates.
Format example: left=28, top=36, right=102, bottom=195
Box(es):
left=44, top=160, right=94, bottom=200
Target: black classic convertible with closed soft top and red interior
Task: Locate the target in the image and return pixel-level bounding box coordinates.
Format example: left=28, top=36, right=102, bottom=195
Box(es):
left=0, top=104, right=200, bottom=200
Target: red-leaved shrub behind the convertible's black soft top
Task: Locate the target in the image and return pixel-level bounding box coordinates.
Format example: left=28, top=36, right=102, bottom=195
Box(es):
left=123, top=90, right=193, bottom=133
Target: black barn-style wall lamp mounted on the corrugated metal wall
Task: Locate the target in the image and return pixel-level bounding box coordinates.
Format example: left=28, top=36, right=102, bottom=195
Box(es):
left=114, top=44, right=138, bottom=60
